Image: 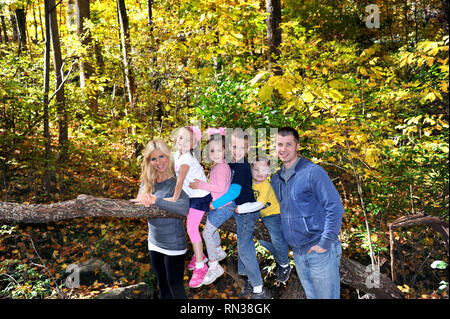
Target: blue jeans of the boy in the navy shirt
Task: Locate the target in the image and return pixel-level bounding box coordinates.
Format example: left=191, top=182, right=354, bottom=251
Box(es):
left=234, top=211, right=263, bottom=287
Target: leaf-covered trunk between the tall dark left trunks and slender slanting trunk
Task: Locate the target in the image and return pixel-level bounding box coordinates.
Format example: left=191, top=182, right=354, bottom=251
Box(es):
left=76, top=0, right=98, bottom=114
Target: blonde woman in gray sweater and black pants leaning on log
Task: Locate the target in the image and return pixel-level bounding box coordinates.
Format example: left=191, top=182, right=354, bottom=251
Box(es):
left=131, top=139, right=189, bottom=299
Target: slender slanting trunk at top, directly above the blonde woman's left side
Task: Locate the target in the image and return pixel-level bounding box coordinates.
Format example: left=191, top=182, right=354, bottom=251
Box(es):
left=116, top=0, right=136, bottom=109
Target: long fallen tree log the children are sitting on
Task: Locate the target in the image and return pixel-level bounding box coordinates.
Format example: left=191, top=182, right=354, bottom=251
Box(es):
left=0, top=195, right=405, bottom=299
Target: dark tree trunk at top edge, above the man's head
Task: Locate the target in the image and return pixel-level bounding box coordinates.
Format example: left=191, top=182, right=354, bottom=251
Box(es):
left=266, top=0, right=283, bottom=75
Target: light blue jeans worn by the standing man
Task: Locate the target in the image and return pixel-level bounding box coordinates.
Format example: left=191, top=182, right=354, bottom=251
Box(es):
left=292, top=241, right=342, bottom=299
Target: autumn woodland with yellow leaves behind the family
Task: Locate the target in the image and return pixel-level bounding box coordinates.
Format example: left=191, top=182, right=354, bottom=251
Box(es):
left=0, top=0, right=449, bottom=298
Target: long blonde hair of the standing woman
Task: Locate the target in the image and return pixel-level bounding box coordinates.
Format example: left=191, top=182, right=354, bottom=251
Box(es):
left=141, top=138, right=175, bottom=193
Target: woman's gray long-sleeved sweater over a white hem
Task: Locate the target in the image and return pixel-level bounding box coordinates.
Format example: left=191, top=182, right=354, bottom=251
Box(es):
left=139, top=178, right=189, bottom=250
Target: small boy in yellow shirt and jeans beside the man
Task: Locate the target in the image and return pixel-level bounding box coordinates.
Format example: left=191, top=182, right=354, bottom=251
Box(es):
left=235, top=157, right=291, bottom=283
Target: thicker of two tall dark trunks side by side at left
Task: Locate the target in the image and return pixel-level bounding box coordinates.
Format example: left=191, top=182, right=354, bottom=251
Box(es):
left=48, top=0, right=69, bottom=163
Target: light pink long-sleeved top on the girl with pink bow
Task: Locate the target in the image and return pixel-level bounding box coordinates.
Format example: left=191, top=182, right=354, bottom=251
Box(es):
left=199, top=161, right=231, bottom=204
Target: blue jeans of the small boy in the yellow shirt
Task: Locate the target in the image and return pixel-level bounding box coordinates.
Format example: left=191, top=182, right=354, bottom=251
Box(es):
left=259, top=214, right=289, bottom=265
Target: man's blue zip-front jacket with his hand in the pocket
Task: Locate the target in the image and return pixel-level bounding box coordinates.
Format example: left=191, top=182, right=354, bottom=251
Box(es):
left=272, top=158, right=344, bottom=252
